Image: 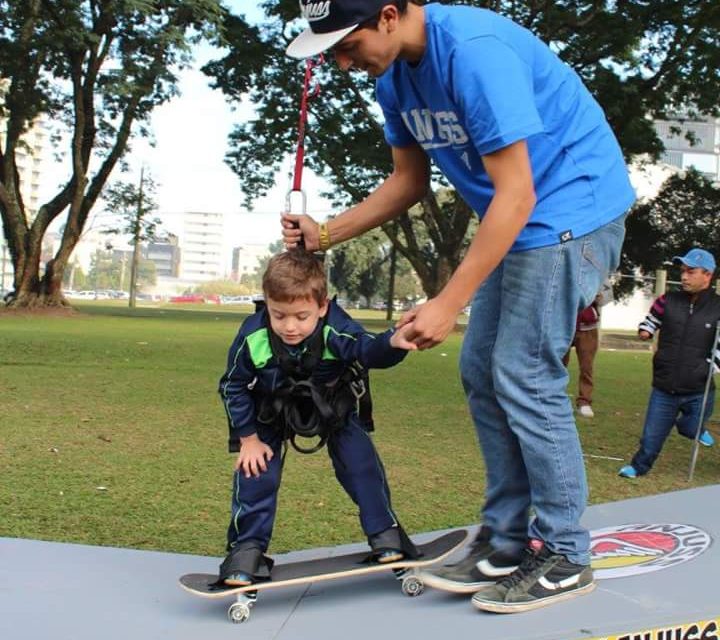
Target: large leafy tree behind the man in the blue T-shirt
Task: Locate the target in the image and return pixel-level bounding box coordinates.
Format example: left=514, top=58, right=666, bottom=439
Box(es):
left=204, top=0, right=720, bottom=295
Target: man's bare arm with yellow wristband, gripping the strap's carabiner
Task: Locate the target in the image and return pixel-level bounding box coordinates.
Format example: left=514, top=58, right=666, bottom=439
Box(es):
left=282, top=145, right=430, bottom=251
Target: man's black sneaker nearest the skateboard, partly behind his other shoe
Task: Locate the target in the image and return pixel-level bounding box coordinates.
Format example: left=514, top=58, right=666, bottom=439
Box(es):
left=422, top=527, right=522, bottom=593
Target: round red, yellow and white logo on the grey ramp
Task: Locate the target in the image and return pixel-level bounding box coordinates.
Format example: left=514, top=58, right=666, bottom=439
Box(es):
left=590, top=524, right=712, bottom=580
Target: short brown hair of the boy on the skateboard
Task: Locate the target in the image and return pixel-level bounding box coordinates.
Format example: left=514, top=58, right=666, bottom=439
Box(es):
left=263, top=249, right=327, bottom=306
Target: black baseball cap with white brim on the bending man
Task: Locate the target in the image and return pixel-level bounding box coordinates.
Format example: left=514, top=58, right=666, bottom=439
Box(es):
left=286, top=0, right=387, bottom=58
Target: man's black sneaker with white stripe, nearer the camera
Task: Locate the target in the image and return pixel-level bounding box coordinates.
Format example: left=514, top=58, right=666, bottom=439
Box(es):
left=472, top=540, right=595, bottom=613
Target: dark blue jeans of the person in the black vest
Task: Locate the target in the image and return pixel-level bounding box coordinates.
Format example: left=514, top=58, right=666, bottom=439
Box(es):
left=631, top=387, right=715, bottom=476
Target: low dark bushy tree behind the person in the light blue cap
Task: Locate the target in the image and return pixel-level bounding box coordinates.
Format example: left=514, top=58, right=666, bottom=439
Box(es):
left=618, top=169, right=720, bottom=294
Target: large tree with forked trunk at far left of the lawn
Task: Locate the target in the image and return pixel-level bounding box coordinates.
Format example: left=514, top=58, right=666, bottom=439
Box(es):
left=0, top=0, right=222, bottom=306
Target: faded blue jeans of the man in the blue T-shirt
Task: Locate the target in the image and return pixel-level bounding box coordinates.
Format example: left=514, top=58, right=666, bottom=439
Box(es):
left=460, top=215, right=625, bottom=565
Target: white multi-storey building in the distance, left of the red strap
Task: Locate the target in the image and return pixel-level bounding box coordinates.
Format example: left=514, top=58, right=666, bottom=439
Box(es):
left=179, top=211, right=225, bottom=282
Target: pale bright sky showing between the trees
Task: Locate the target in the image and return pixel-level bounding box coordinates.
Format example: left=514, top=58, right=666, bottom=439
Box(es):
left=45, top=0, right=331, bottom=260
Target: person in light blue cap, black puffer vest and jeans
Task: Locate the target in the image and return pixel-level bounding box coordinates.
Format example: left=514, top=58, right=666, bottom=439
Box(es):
left=620, top=248, right=720, bottom=478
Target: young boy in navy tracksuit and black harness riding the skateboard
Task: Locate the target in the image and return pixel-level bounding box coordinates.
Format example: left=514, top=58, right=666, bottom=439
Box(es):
left=219, top=249, right=415, bottom=586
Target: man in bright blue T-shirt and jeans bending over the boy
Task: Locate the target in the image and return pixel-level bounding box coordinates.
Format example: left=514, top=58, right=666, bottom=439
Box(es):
left=283, top=0, right=634, bottom=612
